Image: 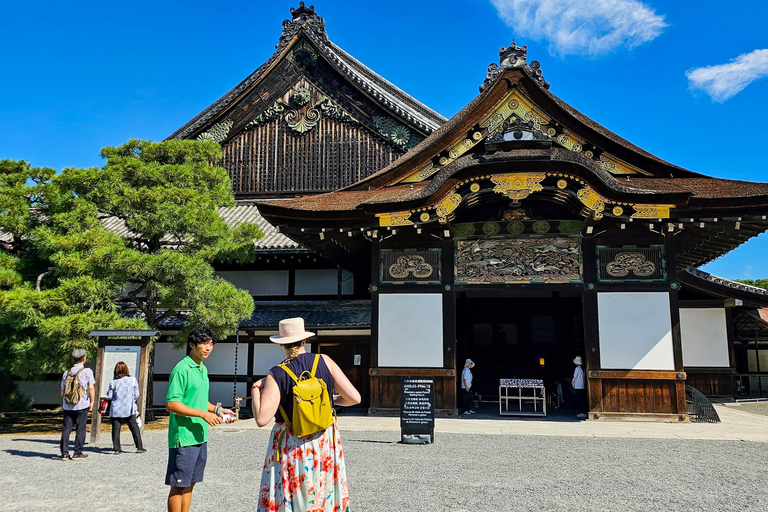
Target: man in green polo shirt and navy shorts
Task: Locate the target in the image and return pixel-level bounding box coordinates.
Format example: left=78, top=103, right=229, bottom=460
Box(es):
left=165, top=326, right=234, bottom=512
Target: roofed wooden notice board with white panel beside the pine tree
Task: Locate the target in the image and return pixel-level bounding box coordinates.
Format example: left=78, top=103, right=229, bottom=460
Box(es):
left=90, top=330, right=158, bottom=443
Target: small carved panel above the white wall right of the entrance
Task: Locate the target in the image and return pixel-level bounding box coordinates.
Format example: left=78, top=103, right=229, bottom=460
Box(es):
left=597, top=246, right=666, bottom=281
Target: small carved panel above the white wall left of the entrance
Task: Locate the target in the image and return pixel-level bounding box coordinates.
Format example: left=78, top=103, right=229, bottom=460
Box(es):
left=379, top=249, right=440, bottom=284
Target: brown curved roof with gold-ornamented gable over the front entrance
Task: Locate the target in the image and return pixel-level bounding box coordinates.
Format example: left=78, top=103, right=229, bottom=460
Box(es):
left=259, top=42, right=768, bottom=268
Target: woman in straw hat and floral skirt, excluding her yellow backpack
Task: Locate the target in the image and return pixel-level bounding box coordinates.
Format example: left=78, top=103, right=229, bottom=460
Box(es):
left=251, top=318, right=360, bottom=512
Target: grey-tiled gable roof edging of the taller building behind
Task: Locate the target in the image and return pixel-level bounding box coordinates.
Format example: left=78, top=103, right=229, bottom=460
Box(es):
left=168, top=2, right=446, bottom=139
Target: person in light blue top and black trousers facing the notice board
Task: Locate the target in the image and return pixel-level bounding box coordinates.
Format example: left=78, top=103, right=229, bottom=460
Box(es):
left=107, top=361, right=147, bottom=455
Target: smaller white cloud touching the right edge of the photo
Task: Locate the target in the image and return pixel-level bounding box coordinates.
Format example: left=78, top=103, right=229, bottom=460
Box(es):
left=685, top=49, right=768, bottom=103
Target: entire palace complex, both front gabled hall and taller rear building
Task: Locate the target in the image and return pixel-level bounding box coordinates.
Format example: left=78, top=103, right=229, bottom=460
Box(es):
left=15, top=2, right=768, bottom=421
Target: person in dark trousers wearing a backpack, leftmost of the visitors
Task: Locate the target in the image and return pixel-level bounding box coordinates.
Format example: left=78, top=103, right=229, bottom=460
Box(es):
left=61, top=348, right=96, bottom=460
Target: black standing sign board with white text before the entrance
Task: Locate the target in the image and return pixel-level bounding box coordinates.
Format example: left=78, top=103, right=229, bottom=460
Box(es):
left=400, top=377, right=435, bottom=443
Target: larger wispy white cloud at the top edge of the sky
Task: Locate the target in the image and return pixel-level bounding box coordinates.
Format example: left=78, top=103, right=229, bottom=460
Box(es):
left=490, top=0, right=667, bottom=57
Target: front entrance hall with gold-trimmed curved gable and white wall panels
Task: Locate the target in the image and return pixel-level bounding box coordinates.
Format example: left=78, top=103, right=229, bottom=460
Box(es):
left=254, top=17, right=768, bottom=420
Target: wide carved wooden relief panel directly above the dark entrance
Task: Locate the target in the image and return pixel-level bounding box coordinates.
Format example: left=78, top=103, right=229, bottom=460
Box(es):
left=456, top=237, right=581, bottom=284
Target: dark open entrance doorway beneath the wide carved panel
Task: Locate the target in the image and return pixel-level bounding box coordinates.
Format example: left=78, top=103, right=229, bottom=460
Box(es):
left=456, top=297, right=585, bottom=401
